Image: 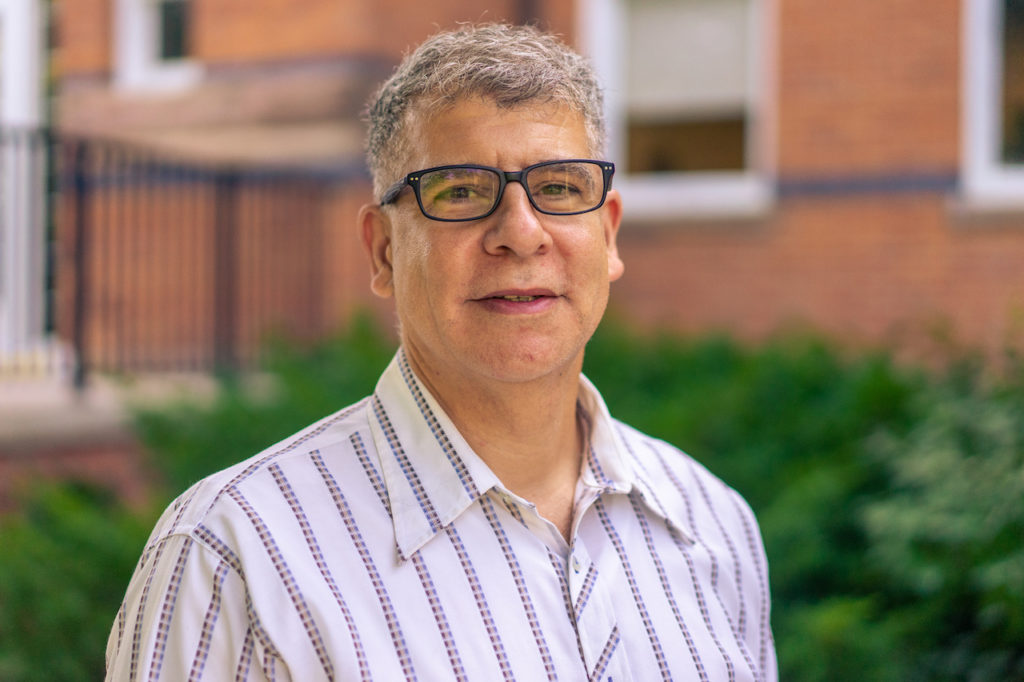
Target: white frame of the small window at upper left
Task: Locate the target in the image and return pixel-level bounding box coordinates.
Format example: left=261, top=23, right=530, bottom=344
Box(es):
left=114, top=0, right=203, bottom=92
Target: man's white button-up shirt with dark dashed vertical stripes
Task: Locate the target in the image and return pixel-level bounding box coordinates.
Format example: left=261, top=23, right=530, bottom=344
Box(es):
left=106, top=350, right=777, bottom=682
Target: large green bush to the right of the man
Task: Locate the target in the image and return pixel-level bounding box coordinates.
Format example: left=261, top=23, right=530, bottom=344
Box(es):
left=586, top=323, right=1024, bottom=682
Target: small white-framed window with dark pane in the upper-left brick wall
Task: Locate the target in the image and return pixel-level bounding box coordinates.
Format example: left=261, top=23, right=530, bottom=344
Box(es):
left=116, top=0, right=202, bottom=91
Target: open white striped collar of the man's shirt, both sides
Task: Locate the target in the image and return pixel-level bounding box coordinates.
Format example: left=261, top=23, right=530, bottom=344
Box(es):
left=367, top=349, right=685, bottom=560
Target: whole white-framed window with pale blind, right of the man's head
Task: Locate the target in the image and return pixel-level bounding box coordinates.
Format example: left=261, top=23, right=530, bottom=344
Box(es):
left=581, top=0, right=770, bottom=218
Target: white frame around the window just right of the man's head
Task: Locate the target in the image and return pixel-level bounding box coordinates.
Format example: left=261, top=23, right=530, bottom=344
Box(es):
left=578, top=0, right=777, bottom=220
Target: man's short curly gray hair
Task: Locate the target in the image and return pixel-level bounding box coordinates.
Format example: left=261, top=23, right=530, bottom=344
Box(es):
left=367, top=24, right=605, bottom=197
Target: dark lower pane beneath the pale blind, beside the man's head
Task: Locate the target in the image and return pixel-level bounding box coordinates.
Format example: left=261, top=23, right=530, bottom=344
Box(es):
left=629, top=116, right=746, bottom=173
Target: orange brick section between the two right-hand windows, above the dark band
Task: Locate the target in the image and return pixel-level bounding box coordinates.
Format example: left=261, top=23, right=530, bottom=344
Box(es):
left=777, top=0, right=961, bottom=175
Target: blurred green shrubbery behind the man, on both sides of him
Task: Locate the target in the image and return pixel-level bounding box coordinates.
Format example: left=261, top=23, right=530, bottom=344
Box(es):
left=0, top=318, right=1024, bottom=682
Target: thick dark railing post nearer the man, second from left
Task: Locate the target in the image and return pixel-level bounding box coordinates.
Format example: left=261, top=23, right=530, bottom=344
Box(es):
left=213, top=168, right=239, bottom=371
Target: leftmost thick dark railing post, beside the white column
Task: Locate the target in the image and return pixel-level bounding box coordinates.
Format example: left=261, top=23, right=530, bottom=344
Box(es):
left=71, top=140, right=90, bottom=391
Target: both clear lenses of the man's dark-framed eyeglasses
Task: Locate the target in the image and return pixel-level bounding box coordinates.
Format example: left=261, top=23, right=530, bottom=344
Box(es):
left=419, top=162, right=604, bottom=220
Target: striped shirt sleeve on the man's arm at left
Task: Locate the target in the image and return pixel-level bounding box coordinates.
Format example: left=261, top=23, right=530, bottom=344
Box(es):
left=106, top=534, right=291, bottom=681
